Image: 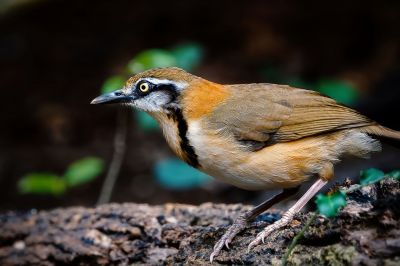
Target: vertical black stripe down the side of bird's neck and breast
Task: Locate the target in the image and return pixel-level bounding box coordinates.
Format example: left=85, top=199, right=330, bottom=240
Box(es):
left=168, top=108, right=200, bottom=168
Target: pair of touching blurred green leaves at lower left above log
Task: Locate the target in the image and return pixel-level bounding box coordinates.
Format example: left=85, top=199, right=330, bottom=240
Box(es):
left=18, top=157, right=104, bottom=195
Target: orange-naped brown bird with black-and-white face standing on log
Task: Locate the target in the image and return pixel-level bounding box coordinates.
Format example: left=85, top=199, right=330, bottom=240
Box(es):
left=91, top=67, right=400, bottom=262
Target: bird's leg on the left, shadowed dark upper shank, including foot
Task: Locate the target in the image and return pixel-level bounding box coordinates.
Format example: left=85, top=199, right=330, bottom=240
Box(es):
left=210, top=187, right=299, bottom=262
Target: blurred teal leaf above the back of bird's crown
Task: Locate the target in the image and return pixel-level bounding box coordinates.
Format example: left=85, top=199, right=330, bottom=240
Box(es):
left=171, top=43, right=204, bottom=71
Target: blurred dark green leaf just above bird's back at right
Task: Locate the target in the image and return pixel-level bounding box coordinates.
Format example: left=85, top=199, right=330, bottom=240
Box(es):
left=317, top=79, right=360, bottom=105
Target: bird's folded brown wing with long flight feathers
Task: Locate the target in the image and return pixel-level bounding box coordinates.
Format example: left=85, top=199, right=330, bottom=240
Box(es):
left=210, top=84, right=375, bottom=146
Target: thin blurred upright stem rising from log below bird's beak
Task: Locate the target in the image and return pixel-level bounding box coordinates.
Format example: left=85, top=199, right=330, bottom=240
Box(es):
left=97, top=109, right=128, bottom=205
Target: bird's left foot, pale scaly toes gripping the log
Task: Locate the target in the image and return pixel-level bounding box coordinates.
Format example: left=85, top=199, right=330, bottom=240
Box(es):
left=210, top=212, right=249, bottom=262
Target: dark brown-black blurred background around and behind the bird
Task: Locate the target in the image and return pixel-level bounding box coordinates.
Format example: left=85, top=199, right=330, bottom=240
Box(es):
left=0, top=0, right=400, bottom=210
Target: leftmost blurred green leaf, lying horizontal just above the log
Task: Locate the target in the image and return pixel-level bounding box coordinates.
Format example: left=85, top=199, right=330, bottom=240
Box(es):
left=18, top=173, right=67, bottom=195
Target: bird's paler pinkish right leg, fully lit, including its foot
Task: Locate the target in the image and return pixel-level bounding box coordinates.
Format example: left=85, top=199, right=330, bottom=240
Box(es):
left=248, top=179, right=328, bottom=250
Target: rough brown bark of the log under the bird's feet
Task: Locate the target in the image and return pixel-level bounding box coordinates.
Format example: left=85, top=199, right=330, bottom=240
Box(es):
left=0, top=179, right=400, bottom=265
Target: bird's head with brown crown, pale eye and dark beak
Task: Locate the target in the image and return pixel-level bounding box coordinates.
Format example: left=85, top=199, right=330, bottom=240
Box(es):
left=91, top=67, right=199, bottom=113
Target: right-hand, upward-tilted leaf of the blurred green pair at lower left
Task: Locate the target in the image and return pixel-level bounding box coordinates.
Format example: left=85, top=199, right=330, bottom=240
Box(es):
left=64, top=157, right=104, bottom=186
